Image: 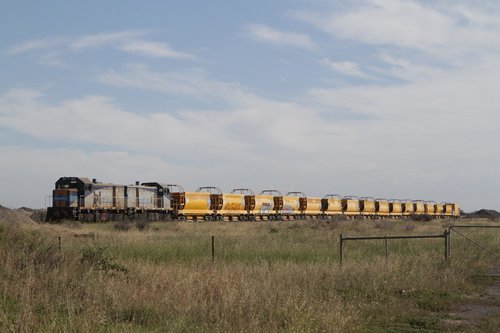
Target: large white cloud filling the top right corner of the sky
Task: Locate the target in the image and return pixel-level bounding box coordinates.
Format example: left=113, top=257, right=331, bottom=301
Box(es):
left=294, top=0, right=500, bottom=65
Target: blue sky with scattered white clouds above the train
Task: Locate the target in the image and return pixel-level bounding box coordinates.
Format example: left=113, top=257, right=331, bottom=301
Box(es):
left=0, top=0, right=500, bottom=211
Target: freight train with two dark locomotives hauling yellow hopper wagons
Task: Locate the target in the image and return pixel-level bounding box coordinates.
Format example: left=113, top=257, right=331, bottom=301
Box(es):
left=47, top=177, right=460, bottom=222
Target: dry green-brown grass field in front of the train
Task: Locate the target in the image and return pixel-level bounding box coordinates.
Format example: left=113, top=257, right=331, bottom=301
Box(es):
left=0, top=217, right=500, bottom=332
